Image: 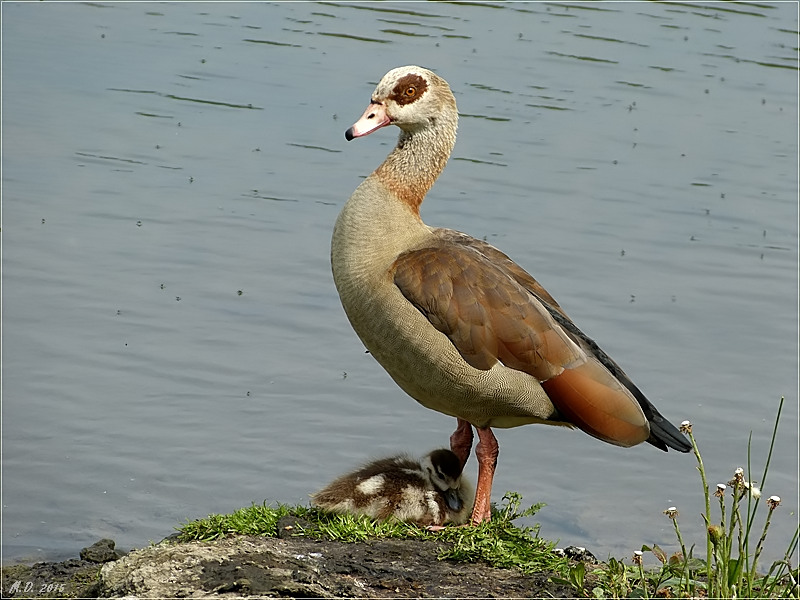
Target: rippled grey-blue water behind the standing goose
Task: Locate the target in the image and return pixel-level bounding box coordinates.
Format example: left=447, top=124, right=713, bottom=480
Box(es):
left=2, top=3, right=798, bottom=561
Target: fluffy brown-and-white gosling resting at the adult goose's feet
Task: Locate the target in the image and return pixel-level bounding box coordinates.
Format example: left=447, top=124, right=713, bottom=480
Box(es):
left=311, top=449, right=475, bottom=527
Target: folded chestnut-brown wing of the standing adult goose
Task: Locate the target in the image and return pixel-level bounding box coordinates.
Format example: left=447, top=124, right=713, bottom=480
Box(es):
left=394, top=230, right=649, bottom=446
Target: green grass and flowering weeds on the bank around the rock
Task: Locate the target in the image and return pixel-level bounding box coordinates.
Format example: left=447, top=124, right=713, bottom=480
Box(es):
left=179, top=398, right=800, bottom=598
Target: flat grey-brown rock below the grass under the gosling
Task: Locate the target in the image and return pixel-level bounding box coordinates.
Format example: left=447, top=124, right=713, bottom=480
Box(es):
left=97, top=536, right=573, bottom=598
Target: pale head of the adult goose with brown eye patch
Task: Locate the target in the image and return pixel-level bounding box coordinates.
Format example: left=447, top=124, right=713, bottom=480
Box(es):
left=345, top=65, right=458, bottom=141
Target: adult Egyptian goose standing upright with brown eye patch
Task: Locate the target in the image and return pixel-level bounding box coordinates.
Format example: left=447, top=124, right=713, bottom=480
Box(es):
left=331, top=66, right=691, bottom=524
